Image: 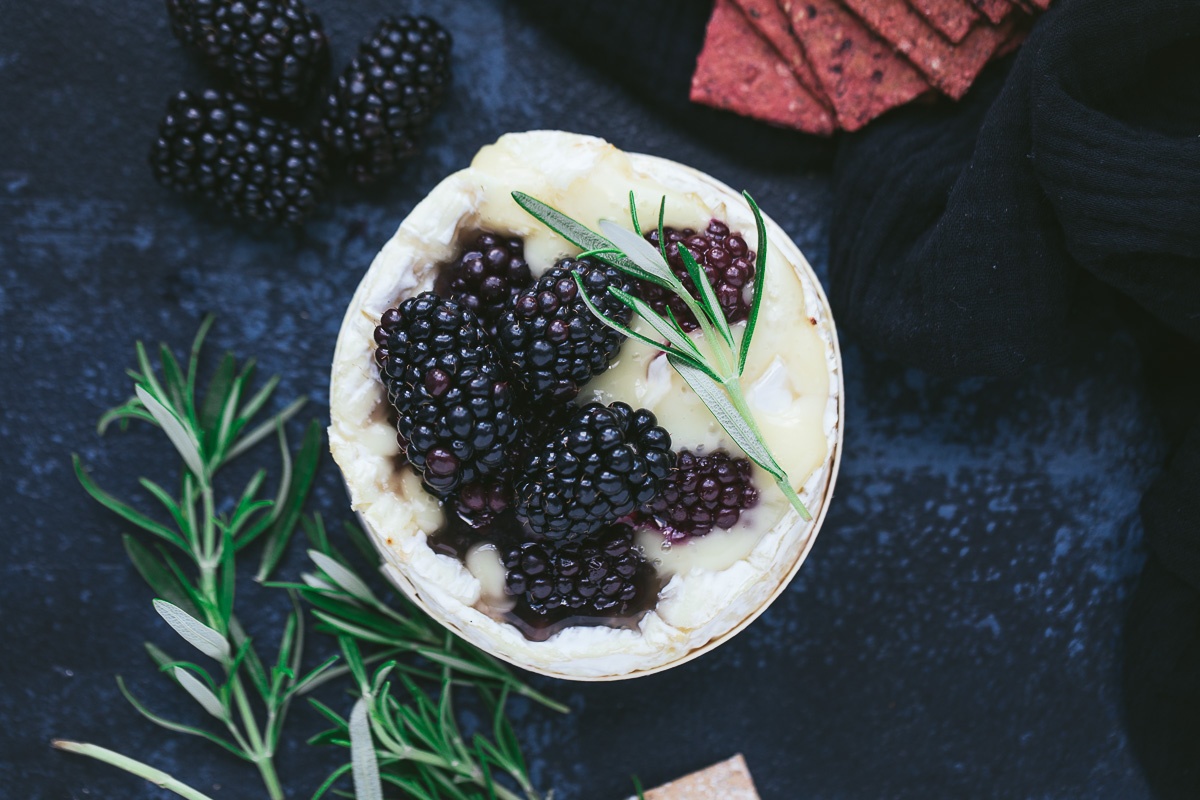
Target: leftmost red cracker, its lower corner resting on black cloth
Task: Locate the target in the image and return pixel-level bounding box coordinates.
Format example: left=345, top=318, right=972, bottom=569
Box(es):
left=691, top=0, right=834, bottom=136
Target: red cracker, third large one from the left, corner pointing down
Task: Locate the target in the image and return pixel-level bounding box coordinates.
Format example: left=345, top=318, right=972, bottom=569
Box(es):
left=842, top=0, right=1013, bottom=100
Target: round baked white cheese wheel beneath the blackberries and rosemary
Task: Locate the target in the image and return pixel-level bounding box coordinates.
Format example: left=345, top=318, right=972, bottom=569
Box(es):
left=329, top=131, right=842, bottom=680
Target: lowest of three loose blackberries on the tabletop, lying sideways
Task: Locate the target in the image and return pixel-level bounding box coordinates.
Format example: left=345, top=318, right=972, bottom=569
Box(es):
left=150, top=90, right=328, bottom=225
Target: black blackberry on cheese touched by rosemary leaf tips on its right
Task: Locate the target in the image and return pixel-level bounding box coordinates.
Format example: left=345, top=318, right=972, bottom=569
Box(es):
left=496, top=258, right=635, bottom=407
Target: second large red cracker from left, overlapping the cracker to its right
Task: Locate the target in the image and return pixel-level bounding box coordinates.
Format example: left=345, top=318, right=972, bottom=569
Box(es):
left=780, top=0, right=929, bottom=131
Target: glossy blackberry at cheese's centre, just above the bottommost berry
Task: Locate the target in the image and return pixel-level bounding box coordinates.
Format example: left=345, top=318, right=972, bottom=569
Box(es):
left=515, top=403, right=672, bottom=541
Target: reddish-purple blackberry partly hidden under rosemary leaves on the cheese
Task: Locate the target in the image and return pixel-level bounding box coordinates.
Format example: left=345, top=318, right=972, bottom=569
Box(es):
left=638, top=219, right=755, bottom=331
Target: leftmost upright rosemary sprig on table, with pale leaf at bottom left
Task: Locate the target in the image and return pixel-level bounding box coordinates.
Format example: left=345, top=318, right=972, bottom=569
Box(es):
left=56, top=317, right=334, bottom=800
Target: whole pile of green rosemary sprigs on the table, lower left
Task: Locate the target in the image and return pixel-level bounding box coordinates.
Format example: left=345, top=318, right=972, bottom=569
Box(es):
left=53, top=319, right=568, bottom=800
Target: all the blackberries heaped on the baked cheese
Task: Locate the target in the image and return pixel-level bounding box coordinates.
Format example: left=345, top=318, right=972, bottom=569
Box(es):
left=376, top=222, right=757, bottom=633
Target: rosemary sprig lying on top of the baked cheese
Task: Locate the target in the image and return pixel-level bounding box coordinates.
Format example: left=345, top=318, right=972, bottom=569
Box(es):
left=512, top=192, right=812, bottom=519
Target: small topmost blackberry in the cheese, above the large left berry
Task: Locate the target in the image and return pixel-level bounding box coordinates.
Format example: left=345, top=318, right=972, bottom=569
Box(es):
left=437, top=231, right=533, bottom=336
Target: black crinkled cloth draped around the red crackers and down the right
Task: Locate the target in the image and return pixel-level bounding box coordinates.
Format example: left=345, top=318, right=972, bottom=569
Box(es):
left=521, top=0, right=1200, bottom=800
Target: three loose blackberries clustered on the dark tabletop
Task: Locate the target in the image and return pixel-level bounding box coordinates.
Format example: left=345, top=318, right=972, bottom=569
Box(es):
left=150, top=0, right=451, bottom=225
